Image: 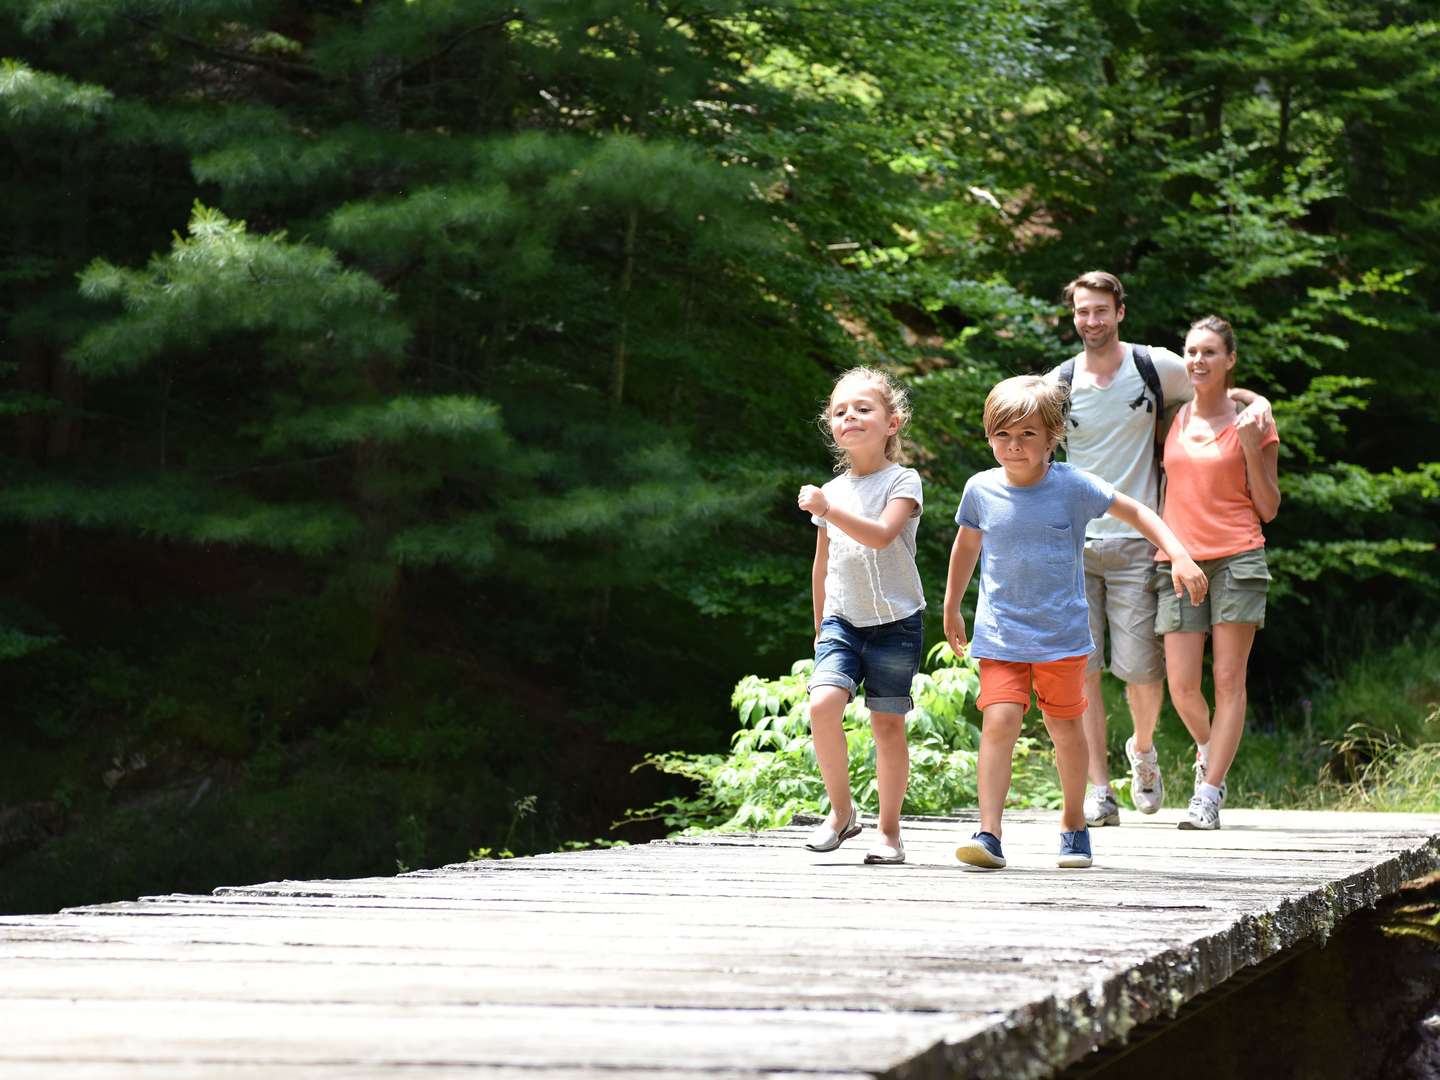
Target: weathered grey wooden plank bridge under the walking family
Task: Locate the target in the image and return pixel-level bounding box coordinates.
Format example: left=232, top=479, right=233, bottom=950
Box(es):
left=0, top=809, right=1440, bottom=1080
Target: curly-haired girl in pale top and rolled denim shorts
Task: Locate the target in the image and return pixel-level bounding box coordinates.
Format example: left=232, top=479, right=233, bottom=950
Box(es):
left=798, top=367, right=924, bottom=864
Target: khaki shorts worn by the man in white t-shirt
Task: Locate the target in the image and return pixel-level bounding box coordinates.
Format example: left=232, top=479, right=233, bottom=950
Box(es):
left=1084, top=537, right=1165, bottom=683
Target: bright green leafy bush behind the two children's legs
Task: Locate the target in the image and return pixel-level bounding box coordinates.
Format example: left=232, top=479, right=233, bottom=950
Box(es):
left=626, top=642, right=1060, bottom=832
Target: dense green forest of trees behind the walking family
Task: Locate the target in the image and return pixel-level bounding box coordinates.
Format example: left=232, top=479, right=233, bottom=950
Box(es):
left=0, top=0, right=1440, bottom=912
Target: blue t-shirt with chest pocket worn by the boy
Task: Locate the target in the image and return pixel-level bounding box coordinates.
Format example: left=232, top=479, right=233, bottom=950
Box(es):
left=955, top=461, right=1115, bottom=664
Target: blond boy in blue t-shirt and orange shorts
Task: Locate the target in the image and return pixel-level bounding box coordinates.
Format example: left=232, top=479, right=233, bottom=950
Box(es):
left=945, top=374, right=1205, bottom=870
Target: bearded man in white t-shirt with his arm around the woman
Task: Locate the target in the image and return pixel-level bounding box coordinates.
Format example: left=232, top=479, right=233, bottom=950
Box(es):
left=1050, top=271, right=1270, bottom=825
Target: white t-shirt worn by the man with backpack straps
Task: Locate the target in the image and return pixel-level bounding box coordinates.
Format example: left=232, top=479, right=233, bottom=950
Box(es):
left=1050, top=343, right=1195, bottom=540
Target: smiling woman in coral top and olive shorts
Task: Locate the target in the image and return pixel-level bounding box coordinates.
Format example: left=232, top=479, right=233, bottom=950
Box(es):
left=1155, top=315, right=1280, bottom=829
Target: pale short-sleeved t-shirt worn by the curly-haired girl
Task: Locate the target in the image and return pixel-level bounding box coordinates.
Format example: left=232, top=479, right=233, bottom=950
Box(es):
left=811, top=462, right=924, bottom=626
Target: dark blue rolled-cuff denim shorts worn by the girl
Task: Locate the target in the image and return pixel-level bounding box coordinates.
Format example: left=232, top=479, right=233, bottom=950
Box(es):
left=809, top=609, right=924, bottom=713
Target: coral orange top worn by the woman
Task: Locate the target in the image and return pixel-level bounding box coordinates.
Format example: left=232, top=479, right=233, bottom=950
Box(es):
left=1156, top=403, right=1280, bottom=560
